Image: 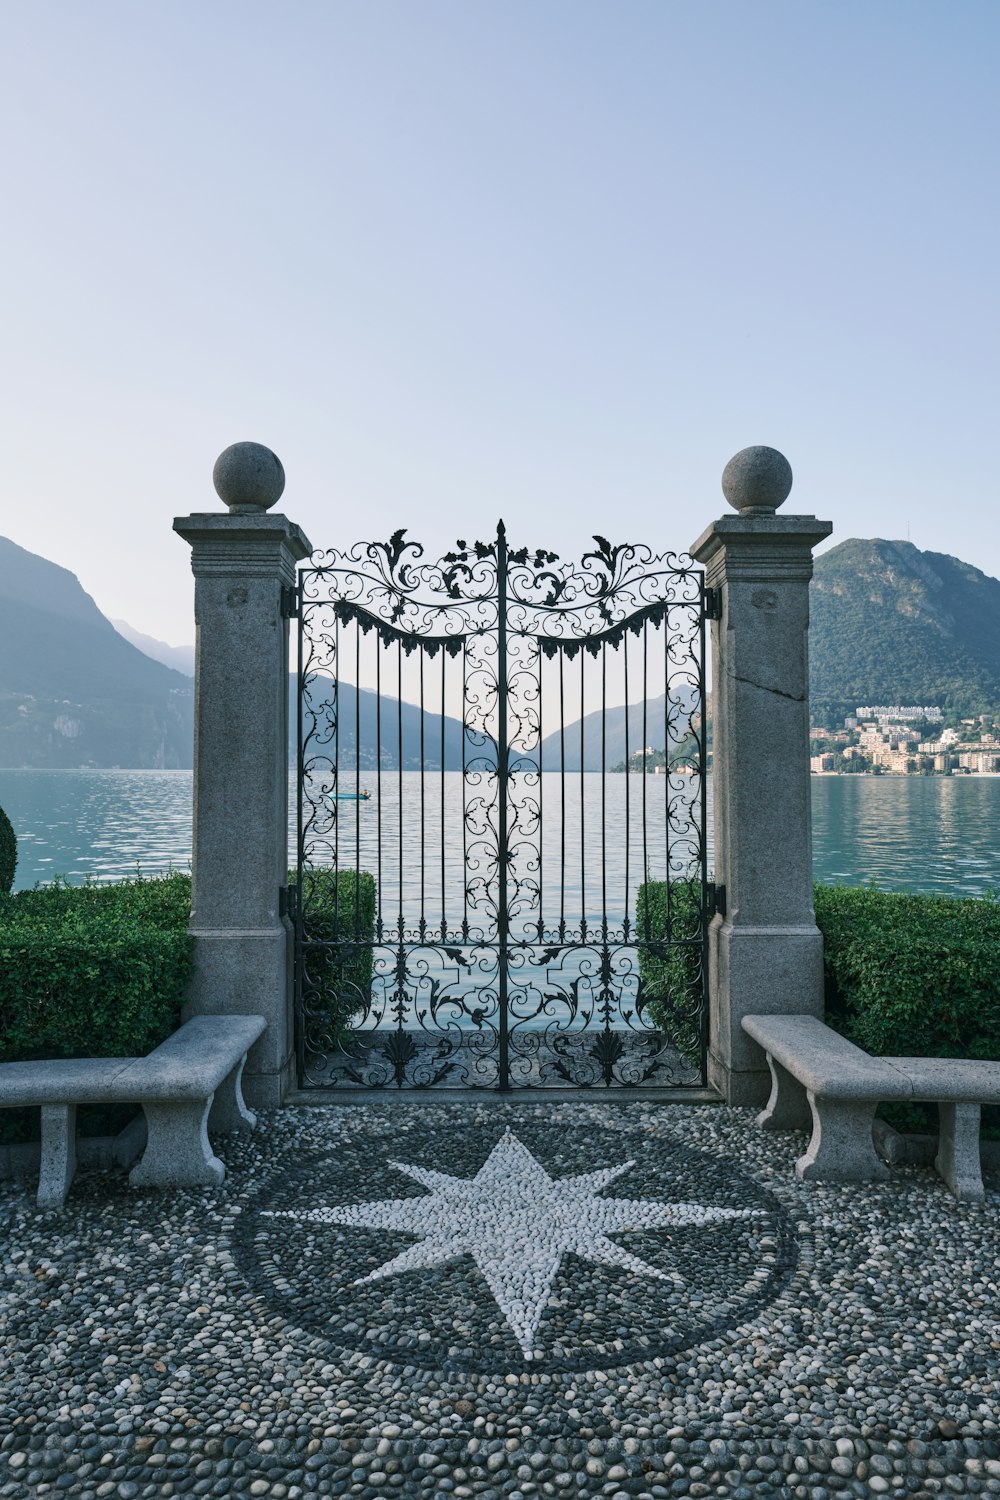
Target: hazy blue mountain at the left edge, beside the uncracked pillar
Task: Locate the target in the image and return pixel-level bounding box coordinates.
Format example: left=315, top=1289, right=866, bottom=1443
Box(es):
left=0, top=537, right=193, bottom=768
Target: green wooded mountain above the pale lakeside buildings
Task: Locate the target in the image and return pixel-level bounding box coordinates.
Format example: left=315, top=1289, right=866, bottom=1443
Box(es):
left=810, top=537, right=1000, bottom=725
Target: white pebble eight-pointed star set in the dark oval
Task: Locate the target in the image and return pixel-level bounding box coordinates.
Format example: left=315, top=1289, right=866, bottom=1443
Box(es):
left=267, top=1131, right=760, bottom=1359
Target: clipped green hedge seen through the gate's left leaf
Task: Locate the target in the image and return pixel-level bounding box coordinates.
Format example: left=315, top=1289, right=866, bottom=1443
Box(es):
left=289, top=870, right=376, bottom=1052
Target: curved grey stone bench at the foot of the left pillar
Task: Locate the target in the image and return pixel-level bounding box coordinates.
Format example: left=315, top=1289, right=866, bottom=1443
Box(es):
left=0, top=1016, right=267, bottom=1208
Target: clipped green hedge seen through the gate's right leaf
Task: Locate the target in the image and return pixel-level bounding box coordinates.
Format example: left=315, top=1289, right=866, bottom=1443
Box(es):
left=636, top=881, right=702, bottom=1068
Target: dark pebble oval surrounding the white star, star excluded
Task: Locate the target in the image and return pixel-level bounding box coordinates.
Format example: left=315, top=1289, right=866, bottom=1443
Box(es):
left=234, top=1118, right=798, bottom=1374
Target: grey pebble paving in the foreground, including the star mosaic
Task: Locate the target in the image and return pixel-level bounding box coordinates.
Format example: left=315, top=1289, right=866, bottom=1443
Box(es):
left=0, top=1097, right=1000, bottom=1500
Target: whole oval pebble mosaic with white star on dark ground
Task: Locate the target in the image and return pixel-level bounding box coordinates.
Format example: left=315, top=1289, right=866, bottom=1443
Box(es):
left=240, top=1118, right=795, bottom=1371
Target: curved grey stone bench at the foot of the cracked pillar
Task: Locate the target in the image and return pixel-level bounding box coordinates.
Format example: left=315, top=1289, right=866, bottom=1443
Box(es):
left=742, top=1016, right=1000, bottom=1203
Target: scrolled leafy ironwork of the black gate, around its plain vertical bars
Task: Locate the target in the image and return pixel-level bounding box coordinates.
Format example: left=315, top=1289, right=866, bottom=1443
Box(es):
left=297, top=524, right=706, bottom=1089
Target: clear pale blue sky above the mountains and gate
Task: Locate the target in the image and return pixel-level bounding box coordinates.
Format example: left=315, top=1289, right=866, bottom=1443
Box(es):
left=0, top=0, right=1000, bottom=642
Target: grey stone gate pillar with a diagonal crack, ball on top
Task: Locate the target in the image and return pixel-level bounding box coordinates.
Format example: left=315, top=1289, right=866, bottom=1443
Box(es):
left=691, top=447, right=834, bottom=1106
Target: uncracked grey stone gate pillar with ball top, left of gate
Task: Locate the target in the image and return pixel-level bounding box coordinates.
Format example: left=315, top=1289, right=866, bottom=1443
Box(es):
left=174, top=443, right=312, bottom=1107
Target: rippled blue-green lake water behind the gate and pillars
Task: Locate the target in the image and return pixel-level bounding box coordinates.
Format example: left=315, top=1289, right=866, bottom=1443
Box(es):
left=0, top=770, right=1000, bottom=894
